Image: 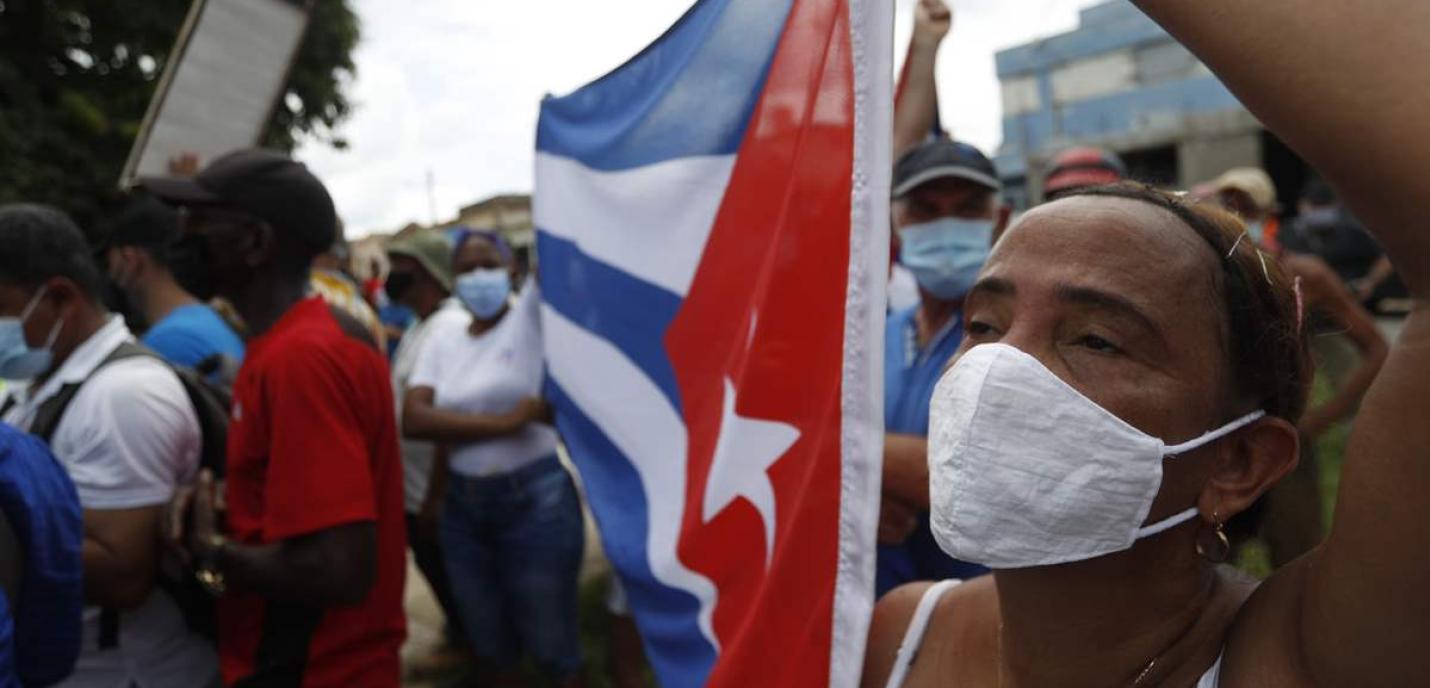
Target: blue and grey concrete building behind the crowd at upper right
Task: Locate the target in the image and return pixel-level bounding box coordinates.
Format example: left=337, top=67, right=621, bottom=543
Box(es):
left=997, top=0, right=1307, bottom=209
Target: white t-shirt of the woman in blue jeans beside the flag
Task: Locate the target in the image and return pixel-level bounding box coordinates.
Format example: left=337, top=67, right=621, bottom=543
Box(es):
left=408, top=285, right=556, bottom=476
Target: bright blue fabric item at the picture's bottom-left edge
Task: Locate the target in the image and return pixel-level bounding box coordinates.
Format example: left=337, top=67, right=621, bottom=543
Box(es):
left=0, top=423, right=84, bottom=687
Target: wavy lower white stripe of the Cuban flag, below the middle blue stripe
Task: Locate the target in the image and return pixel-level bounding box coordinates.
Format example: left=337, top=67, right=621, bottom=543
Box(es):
left=541, top=303, right=719, bottom=654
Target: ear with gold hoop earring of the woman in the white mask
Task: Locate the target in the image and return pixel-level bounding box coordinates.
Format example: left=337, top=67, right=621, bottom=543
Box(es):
left=1197, top=416, right=1301, bottom=522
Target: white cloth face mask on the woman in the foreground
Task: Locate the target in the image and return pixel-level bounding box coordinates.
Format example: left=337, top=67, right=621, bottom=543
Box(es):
left=928, top=343, right=1266, bottom=569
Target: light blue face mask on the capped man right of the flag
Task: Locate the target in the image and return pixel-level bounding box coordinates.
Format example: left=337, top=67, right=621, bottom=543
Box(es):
left=899, top=217, right=994, bottom=299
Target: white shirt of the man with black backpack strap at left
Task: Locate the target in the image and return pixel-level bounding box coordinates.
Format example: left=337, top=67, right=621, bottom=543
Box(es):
left=4, top=316, right=217, bottom=688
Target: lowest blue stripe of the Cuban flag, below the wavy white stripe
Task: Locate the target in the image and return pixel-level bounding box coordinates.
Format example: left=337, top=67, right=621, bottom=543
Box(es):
left=542, top=377, right=715, bottom=687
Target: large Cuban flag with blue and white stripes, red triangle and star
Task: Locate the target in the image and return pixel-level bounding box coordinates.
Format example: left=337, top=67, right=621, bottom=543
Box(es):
left=533, top=0, right=892, bottom=687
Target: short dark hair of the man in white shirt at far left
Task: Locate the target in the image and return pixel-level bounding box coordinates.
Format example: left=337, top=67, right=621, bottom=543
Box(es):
left=0, top=203, right=102, bottom=299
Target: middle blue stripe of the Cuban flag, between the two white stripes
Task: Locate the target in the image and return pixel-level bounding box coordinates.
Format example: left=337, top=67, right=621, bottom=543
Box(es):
left=536, top=229, right=682, bottom=413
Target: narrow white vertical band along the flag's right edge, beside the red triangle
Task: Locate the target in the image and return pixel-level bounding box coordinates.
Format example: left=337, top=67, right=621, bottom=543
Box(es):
left=829, top=0, right=894, bottom=688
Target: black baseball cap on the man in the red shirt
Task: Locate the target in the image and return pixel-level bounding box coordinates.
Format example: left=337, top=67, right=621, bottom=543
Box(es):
left=139, top=149, right=337, bottom=250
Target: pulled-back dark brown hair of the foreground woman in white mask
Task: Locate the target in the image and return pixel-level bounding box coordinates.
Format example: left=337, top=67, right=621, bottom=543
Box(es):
left=1068, top=183, right=1311, bottom=423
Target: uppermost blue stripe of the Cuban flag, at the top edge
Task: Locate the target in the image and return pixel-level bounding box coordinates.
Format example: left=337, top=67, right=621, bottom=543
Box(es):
left=536, top=0, right=792, bottom=170
